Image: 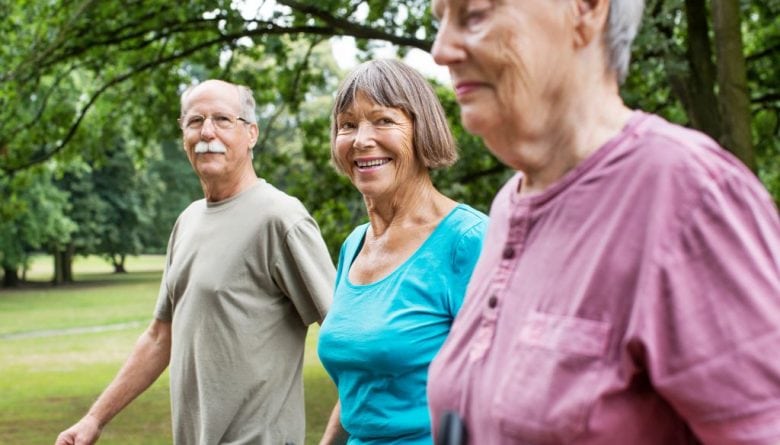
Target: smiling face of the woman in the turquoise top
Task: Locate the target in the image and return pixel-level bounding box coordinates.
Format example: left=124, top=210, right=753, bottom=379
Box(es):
left=333, top=93, right=427, bottom=200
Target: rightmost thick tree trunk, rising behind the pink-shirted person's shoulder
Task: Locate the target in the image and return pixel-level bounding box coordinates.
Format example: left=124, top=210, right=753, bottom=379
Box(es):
left=712, top=0, right=756, bottom=171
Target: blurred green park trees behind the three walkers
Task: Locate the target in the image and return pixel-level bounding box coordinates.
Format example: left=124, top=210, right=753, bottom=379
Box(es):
left=0, top=0, right=780, bottom=286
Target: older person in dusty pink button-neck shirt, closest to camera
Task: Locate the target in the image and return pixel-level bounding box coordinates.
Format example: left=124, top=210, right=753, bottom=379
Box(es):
left=428, top=0, right=780, bottom=445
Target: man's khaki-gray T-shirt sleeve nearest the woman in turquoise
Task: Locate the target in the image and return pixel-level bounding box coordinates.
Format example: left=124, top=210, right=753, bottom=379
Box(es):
left=274, top=217, right=335, bottom=325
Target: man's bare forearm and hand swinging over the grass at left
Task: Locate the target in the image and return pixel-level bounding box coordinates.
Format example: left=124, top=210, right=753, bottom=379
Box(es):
left=55, top=320, right=171, bottom=445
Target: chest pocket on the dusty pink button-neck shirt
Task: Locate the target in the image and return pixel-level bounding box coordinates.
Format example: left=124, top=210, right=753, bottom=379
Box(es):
left=492, top=312, right=610, bottom=444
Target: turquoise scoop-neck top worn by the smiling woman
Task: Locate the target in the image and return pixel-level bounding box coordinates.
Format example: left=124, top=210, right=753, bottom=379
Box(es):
left=318, top=204, right=487, bottom=445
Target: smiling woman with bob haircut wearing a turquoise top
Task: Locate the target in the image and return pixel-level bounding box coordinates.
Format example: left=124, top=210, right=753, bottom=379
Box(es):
left=318, top=60, right=487, bottom=444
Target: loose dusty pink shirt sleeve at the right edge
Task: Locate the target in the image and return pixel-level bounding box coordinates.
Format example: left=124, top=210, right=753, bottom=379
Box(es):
left=646, top=169, right=780, bottom=444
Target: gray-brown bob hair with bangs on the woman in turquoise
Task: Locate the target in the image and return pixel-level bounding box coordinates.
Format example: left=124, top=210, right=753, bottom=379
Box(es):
left=330, top=59, right=458, bottom=173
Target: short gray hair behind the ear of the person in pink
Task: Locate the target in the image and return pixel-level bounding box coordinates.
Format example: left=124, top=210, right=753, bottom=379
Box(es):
left=604, top=0, right=645, bottom=83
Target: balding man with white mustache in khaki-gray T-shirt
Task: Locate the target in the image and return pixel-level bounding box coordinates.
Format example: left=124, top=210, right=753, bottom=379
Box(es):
left=56, top=80, right=334, bottom=445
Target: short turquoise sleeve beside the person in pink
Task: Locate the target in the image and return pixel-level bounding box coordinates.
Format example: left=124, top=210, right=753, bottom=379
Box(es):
left=447, top=219, right=487, bottom=318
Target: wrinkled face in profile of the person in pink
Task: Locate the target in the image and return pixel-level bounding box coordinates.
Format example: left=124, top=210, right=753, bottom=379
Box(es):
left=432, top=0, right=576, bottom=165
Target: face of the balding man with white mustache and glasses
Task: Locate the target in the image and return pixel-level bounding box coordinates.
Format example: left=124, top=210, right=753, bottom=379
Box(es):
left=182, top=80, right=257, bottom=183
